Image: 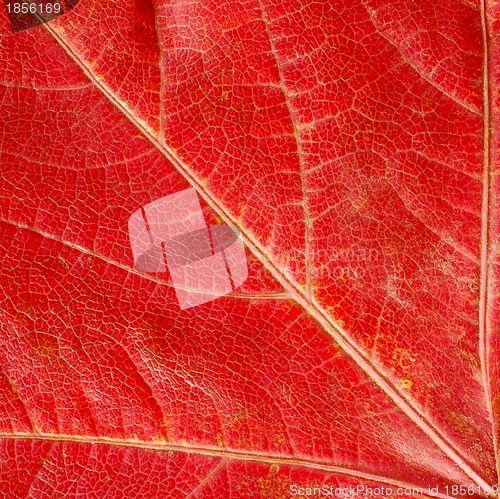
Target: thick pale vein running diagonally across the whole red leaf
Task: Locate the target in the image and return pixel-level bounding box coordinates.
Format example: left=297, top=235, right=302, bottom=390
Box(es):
left=39, top=23, right=490, bottom=489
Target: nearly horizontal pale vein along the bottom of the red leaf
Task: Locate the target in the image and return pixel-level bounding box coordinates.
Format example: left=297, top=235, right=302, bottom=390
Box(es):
left=0, top=433, right=455, bottom=499
